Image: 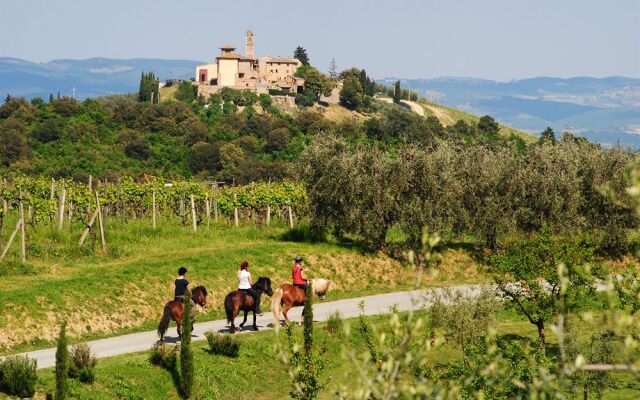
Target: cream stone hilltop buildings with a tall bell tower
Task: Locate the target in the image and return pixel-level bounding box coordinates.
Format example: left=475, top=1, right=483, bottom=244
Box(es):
left=195, top=30, right=304, bottom=97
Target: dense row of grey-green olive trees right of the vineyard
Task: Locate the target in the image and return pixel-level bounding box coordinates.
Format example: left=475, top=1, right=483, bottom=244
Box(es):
left=303, top=133, right=638, bottom=256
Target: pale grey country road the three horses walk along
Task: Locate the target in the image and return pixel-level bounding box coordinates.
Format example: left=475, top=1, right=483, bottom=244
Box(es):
left=6, top=285, right=487, bottom=368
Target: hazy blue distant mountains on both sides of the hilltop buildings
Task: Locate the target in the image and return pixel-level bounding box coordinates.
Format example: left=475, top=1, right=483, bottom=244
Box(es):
left=0, top=57, right=640, bottom=148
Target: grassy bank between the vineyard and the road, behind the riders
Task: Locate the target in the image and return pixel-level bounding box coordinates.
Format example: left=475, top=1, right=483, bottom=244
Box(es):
left=0, top=219, right=481, bottom=353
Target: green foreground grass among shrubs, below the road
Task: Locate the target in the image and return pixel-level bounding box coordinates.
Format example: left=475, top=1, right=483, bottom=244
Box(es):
left=31, top=312, right=640, bottom=400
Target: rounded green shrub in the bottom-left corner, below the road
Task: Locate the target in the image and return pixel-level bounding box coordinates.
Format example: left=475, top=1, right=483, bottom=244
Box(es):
left=0, top=356, right=38, bottom=397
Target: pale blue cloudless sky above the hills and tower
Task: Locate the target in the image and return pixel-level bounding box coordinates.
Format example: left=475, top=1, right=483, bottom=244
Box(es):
left=0, top=0, right=640, bottom=81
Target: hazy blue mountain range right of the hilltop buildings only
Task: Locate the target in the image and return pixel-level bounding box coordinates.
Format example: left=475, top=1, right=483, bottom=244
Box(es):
left=380, top=77, right=640, bottom=148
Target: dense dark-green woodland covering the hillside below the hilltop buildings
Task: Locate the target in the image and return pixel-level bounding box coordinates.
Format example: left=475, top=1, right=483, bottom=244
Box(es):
left=0, top=91, right=350, bottom=183
